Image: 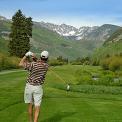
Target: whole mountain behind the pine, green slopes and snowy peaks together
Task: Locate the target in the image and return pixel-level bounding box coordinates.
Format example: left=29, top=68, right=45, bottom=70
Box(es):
left=0, top=17, right=119, bottom=59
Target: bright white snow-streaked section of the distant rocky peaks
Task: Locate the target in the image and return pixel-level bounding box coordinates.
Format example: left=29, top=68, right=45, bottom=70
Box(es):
left=40, top=22, right=101, bottom=40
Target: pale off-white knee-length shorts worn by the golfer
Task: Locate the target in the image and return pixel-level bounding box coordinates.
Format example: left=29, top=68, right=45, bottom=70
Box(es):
left=24, top=83, right=43, bottom=106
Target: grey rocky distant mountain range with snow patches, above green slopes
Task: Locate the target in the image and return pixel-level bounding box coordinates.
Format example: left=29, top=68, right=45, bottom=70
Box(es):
left=36, top=22, right=119, bottom=41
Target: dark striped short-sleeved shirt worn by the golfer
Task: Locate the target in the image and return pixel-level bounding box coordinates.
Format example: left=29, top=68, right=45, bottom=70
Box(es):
left=24, top=60, right=49, bottom=85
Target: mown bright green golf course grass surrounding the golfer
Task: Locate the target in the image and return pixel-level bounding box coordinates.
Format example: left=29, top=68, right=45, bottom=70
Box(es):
left=0, top=65, right=122, bottom=122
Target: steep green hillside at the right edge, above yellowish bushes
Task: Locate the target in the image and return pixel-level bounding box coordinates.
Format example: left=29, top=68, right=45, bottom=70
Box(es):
left=93, top=28, right=122, bottom=59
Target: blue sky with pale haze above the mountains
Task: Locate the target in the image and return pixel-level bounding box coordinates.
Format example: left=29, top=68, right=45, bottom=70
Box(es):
left=0, top=0, right=122, bottom=27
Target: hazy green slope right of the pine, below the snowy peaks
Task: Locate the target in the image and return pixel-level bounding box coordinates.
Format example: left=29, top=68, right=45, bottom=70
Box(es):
left=31, top=26, right=91, bottom=59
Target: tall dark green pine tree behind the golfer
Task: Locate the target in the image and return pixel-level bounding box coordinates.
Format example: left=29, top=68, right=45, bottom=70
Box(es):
left=9, top=10, right=33, bottom=57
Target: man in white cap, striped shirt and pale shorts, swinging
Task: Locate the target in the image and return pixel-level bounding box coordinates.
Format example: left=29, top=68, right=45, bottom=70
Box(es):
left=19, top=51, right=49, bottom=122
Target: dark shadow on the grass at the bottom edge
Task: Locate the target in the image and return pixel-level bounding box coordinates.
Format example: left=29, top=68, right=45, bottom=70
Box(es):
left=40, top=112, right=76, bottom=122
